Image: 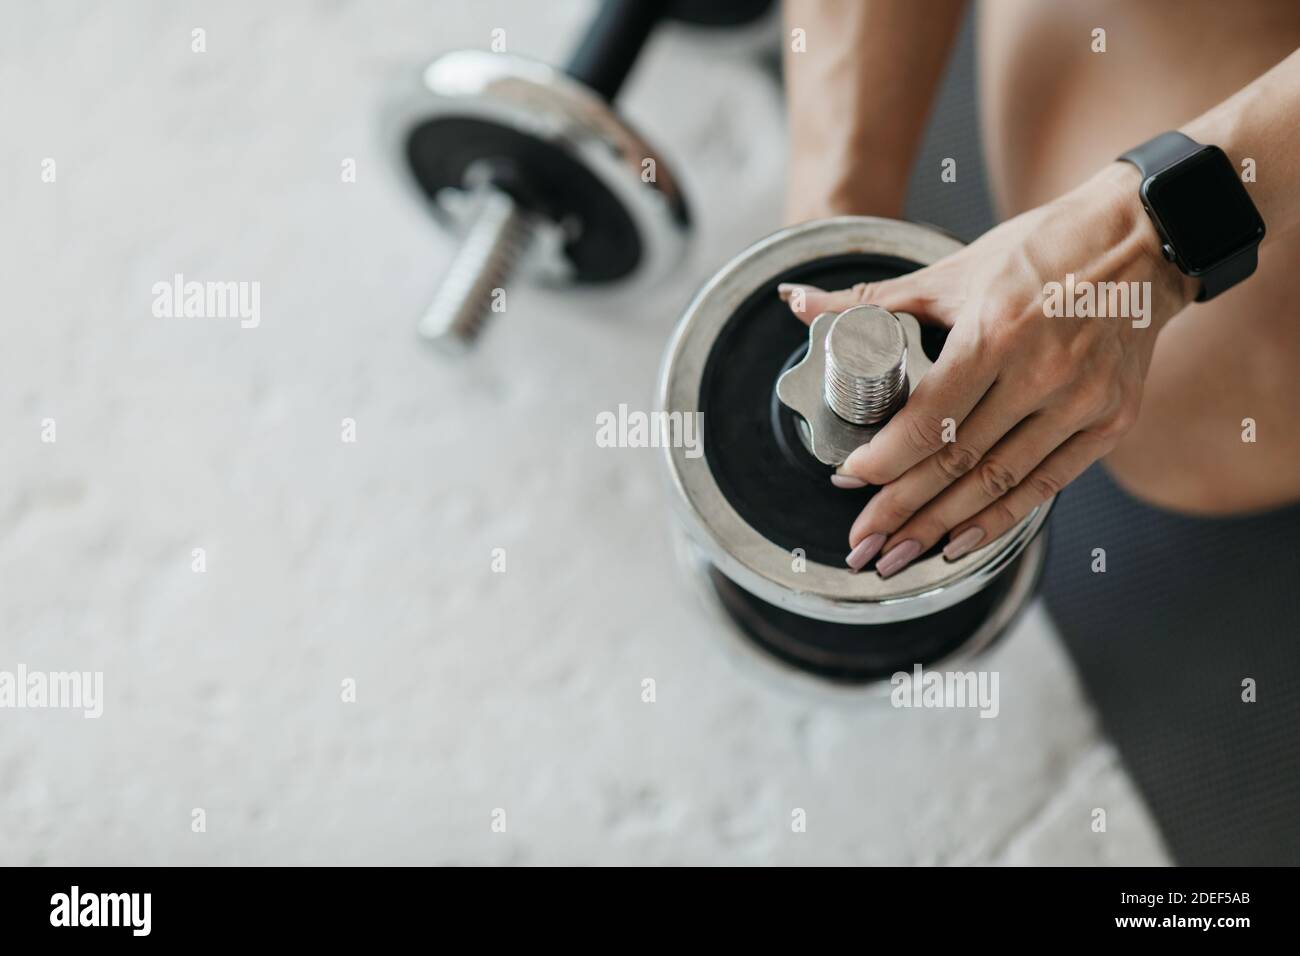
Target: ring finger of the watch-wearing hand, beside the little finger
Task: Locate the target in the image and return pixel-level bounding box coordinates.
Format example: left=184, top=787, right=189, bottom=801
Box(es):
left=876, top=412, right=1076, bottom=578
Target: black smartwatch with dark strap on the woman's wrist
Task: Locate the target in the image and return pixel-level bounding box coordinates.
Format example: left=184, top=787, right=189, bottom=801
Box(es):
left=1119, top=133, right=1264, bottom=302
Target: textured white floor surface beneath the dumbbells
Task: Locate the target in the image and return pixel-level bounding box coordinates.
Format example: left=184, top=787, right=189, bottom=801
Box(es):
left=0, top=0, right=1165, bottom=864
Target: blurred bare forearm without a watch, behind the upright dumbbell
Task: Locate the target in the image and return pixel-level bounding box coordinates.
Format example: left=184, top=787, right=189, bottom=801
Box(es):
left=785, top=0, right=965, bottom=221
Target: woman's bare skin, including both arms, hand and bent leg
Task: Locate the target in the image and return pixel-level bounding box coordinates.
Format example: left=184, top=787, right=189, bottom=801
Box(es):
left=783, top=0, right=1300, bottom=576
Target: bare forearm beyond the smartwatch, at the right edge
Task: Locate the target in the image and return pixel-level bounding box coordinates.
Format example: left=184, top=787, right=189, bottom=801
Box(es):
left=1182, top=51, right=1300, bottom=237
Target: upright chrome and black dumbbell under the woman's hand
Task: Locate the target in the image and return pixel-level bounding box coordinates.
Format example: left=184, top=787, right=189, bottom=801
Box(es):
left=659, top=216, right=1052, bottom=684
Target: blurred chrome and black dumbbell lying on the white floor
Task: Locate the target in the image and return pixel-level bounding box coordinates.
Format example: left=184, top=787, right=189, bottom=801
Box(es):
left=399, top=0, right=771, bottom=351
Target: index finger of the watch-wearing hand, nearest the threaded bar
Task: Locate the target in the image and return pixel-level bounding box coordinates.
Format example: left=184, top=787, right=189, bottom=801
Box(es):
left=840, top=333, right=997, bottom=485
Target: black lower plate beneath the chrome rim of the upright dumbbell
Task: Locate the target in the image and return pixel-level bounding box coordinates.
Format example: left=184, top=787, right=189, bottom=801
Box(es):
left=709, top=548, right=1023, bottom=684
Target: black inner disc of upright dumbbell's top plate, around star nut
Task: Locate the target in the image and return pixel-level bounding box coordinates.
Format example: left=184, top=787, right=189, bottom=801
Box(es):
left=699, top=254, right=945, bottom=567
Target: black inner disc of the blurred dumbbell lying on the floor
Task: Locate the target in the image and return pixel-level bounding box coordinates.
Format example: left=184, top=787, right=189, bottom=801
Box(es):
left=406, top=116, right=641, bottom=282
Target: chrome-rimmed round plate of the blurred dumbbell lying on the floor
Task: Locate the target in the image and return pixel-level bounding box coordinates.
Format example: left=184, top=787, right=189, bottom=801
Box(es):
left=390, top=51, right=689, bottom=282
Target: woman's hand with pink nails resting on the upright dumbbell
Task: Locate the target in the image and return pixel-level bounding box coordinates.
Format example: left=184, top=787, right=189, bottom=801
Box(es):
left=781, top=163, right=1197, bottom=576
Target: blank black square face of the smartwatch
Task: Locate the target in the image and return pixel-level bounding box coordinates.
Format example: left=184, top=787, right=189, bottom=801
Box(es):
left=1143, top=146, right=1264, bottom=273
